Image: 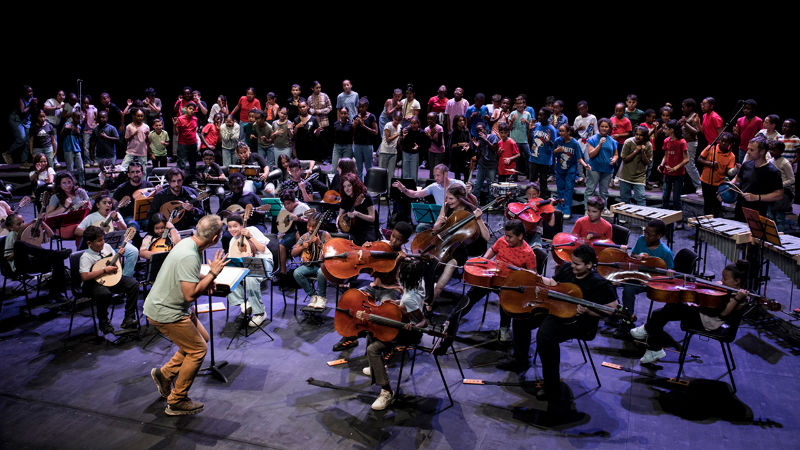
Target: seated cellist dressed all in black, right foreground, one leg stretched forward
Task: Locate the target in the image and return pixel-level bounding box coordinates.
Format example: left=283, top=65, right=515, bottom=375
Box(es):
left=536, top=244, right=617, bottom=424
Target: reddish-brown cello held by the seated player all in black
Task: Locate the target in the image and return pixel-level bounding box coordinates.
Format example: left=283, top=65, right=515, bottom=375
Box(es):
left=500, top=271, right=635, bottom=322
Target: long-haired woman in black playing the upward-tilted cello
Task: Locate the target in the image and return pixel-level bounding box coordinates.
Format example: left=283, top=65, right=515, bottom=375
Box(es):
left=432, top=184, right=489, bottom=299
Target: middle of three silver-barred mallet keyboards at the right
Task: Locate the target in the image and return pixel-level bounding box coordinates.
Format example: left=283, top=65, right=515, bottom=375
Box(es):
left=688, top=215, right=750, bottom=272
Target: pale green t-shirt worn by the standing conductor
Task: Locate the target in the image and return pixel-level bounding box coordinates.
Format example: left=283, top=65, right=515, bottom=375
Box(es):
left=143, top=238, right=200, bottom=323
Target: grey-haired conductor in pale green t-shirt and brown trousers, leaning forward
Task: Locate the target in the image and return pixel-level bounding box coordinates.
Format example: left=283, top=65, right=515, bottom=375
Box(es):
left=144, top=215, right=228, bottom=416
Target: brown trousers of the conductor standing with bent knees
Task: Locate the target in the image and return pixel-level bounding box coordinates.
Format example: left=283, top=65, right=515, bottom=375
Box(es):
left=147, top=314, right=208, bottom=405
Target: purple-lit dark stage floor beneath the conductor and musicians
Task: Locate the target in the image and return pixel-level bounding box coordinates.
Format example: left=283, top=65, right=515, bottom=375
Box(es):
left=0, top=198, right=800, bottom=449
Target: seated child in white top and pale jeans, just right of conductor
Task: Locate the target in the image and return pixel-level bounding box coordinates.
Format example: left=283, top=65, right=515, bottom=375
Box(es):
left=228, top=214, right=273, bottom=327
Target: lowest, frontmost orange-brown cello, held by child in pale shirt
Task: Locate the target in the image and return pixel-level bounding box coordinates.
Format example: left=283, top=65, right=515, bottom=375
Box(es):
left=333, top=289, right=446, bottom=342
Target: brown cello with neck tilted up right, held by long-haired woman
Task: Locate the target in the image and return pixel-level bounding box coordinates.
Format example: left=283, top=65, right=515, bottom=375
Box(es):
left=411, top=194, right=509, bottom=261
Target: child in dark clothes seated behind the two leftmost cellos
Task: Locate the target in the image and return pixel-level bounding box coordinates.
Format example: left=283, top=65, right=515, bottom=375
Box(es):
left=333, top=223, right=416, bottom=352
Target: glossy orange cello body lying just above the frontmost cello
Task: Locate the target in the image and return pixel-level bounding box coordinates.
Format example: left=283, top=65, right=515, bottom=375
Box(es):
left=322, top=238, right=401, bottom=280
